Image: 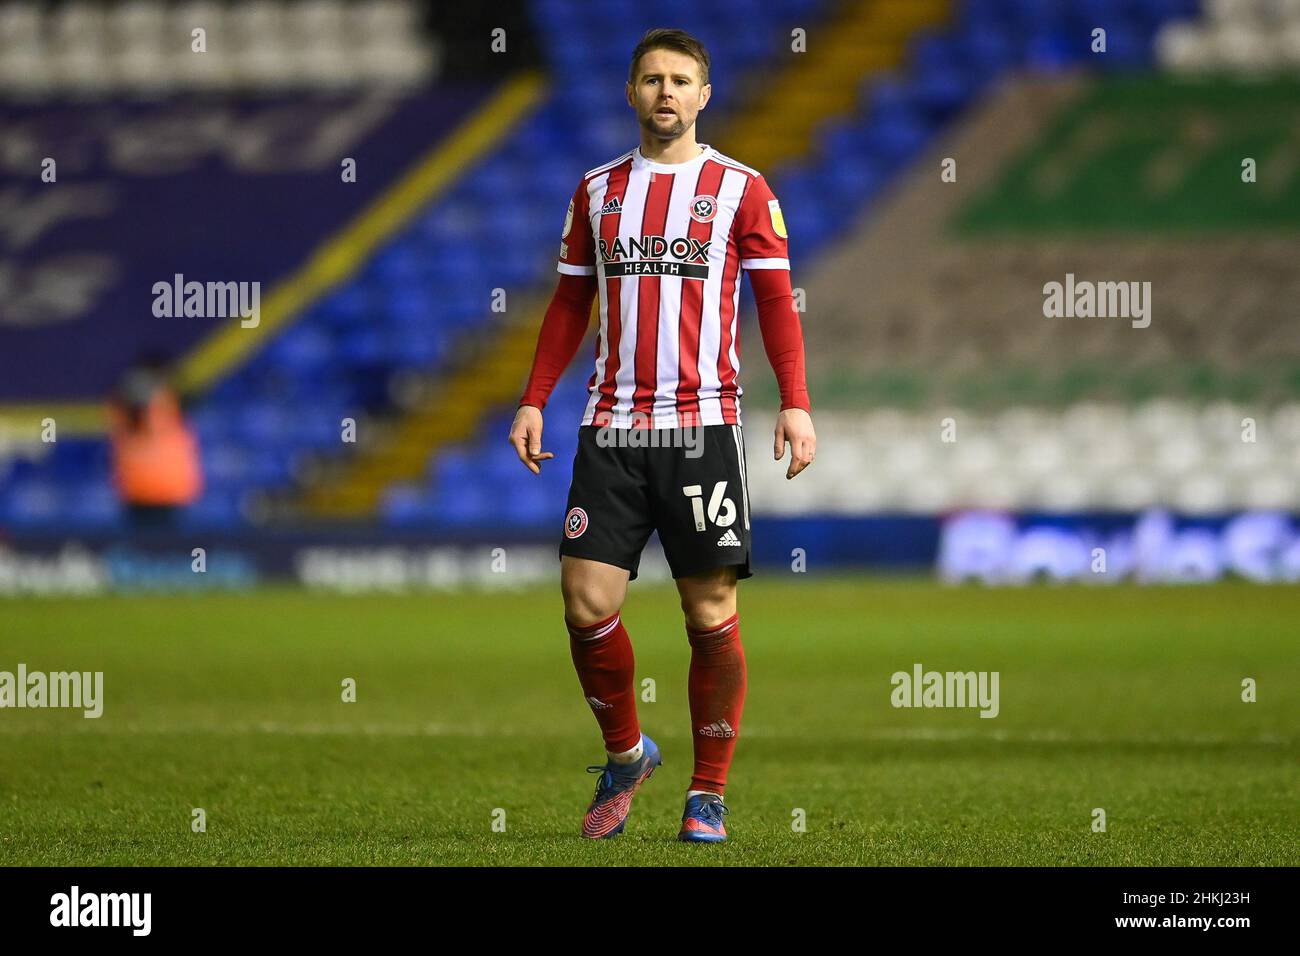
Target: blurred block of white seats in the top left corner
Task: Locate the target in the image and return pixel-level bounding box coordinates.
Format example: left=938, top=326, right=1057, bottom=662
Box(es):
left=0, top=0, right=439, bottom=100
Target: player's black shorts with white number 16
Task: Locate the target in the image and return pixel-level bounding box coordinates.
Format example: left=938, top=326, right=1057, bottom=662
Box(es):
left=560, top=425, right=754, bottom=580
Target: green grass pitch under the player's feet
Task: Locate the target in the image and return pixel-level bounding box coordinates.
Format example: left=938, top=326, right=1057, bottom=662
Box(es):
left=0, top=572, right=1300, bottom=865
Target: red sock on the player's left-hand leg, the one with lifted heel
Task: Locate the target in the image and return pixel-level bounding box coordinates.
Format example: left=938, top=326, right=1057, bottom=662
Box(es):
left=564, top=614, right=641, bottom=753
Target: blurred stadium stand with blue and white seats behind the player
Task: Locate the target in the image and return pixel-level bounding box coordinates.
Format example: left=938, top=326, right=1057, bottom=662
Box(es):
left=0, top=0, right=1300, bottom=538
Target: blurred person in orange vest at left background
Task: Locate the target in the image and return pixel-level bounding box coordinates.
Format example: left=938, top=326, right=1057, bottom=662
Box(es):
left=108, top=355, right=203, bottom=528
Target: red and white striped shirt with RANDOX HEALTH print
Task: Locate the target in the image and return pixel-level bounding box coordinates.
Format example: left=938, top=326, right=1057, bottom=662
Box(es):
left=556, top=146, right=802, bottom=428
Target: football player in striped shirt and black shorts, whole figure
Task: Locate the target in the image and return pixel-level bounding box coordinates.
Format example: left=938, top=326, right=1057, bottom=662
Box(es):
left=510, top=30, right=816, bottom=843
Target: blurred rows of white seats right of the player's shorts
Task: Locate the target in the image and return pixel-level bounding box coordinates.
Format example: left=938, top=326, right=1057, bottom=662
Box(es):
left=746, top=401, right=1300, bottom=514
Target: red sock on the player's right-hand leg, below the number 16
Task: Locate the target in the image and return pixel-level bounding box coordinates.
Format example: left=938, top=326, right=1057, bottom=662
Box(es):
left=686, top=614, right=745, bottom=795
